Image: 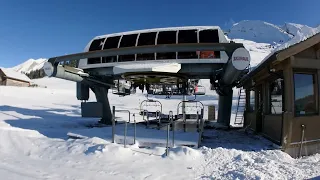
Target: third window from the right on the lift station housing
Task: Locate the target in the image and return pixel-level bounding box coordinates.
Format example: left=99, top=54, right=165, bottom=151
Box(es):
left=157, top=31, right=177, bottom=59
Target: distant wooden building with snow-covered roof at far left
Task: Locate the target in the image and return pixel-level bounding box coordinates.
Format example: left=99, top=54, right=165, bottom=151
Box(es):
left=0, top=68, right=31, bottom=87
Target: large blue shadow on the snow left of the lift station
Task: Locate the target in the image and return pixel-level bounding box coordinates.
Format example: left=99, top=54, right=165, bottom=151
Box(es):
left=0, top=106, right=97, bottom=139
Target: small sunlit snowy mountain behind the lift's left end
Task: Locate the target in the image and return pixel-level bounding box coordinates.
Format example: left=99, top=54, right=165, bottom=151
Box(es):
left=12, top=58, right=47, bottom=73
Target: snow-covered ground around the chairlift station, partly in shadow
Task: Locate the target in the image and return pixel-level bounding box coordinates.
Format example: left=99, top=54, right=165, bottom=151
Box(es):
left=0, top=78, right=320, bottom=180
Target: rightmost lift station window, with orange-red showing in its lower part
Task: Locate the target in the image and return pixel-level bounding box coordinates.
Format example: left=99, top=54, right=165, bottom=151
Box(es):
left=199, top=29, right=220, bottom=59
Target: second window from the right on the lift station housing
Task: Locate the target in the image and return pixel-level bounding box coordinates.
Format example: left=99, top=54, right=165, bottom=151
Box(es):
left=178, top=29, right=198, bottom=59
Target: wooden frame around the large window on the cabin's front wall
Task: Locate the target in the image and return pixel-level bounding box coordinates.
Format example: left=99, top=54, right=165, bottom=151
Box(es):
left=292, top=69, right=319, bottom=117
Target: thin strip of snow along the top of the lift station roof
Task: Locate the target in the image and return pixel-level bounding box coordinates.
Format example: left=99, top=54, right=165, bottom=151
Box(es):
left=93, top=26, right=221, bottom=39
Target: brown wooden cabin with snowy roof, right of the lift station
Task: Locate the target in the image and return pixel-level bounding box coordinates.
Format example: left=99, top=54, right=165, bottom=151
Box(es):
left=238, top=33, right=320, bottom=157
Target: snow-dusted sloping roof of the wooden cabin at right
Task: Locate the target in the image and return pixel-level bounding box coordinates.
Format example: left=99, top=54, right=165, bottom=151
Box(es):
left=238, top=27, right=320, bottom=87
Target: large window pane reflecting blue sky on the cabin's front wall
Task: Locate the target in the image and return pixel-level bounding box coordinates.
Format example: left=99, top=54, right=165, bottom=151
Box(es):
left=294, top=73, right=317, bottom=116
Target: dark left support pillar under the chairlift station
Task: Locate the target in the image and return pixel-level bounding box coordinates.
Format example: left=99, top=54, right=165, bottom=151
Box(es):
left=92, top=86, right=112, bottom=125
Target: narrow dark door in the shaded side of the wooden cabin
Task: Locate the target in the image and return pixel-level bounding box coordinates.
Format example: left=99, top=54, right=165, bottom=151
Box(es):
left=256, top=85, right=264, bottom=132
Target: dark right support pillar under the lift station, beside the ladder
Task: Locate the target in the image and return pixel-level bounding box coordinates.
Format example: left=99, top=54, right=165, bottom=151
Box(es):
left=218, top=88, right=233, bottom=127
